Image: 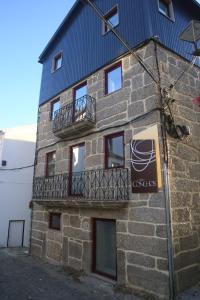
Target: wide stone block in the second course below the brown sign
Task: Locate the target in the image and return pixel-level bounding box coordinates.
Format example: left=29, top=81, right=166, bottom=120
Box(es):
left=129, top=207, right=166, bottom=224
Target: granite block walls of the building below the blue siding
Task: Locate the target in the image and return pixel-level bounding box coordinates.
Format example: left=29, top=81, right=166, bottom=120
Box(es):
left=31, top=42, right=200, bottom=299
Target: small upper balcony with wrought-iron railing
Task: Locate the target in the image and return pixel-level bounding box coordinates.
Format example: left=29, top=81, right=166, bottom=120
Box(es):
left=53, top=95, right=96, bottom=138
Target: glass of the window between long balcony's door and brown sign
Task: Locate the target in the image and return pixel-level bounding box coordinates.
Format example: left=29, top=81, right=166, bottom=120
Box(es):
left=107, top=136, right=124, bottom=168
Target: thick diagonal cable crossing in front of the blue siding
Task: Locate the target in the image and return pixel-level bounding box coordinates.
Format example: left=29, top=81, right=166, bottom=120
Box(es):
left=82, top=0, right=158, bottom=83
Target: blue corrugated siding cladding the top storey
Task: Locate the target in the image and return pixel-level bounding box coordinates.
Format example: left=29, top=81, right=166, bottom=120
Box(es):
left=40, top=0, right=200, bottom=104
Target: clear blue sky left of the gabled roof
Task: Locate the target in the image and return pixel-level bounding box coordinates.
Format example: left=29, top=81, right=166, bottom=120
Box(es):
left=0, top=0, right=200, bottom=130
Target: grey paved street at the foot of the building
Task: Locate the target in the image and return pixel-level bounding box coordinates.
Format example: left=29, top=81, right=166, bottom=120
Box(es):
left=0, top=249, right=200, bottom=300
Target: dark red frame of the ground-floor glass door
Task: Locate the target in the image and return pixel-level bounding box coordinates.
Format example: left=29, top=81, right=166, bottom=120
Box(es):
left=92, top=218, right=117, bottom=281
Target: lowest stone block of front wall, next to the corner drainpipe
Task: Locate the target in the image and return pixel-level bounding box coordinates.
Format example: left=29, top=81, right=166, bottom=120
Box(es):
left=127, top=265, right=169, bottom=296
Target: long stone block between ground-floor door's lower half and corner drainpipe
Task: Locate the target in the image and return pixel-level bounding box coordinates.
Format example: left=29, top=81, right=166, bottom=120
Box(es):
left=117, top=233, right=167, bottom=258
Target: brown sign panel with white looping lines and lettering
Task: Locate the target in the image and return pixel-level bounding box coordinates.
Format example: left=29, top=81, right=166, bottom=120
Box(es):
left=131, top=139, right=158, bottom=193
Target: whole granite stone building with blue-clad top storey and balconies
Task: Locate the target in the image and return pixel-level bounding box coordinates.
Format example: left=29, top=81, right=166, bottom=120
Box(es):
left=31, top=0, right=200, bottom=299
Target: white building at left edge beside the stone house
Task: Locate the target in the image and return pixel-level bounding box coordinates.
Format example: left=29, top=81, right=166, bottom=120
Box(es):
left=0, top=125, right=36, bottom=247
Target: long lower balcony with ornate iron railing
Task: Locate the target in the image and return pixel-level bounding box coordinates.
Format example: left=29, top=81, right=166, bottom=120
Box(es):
left=33, top=168, right=129, bottom=207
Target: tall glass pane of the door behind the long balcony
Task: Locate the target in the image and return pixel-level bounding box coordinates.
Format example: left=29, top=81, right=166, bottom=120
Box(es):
left=71, top=145, right=85, bottom=195
